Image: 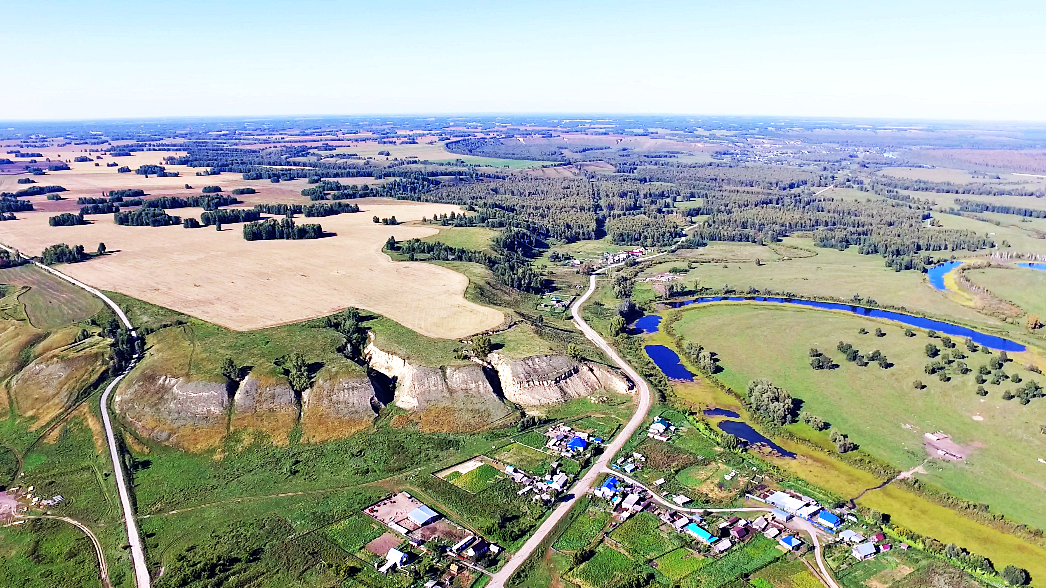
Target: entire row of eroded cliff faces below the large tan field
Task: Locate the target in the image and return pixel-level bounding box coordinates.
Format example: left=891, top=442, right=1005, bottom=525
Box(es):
left=114, top=343, right=632, bottom=451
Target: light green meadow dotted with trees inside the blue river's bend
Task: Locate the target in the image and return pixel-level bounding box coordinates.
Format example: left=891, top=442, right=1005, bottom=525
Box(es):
left=675, top=304, right=1046, bottom=527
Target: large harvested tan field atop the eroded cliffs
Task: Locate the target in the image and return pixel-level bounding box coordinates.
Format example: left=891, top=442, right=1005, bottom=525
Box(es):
left=0, top=197, right=504, bottom=339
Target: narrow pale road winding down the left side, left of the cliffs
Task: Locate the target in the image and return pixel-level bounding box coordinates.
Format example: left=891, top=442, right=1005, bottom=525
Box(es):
left=0, top=252, right=152, bottom=588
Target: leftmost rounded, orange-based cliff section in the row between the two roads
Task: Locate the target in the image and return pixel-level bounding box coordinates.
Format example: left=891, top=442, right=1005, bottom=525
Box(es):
left=113, top=371, right=229, bottom=451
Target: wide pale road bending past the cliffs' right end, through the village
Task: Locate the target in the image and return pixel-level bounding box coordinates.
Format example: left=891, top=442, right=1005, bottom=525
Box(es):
left=487, top=274, right=653, bottom=588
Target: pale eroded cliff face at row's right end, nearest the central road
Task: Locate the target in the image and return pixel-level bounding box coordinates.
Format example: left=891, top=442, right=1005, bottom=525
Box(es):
left=488, top=354, right=633, bottom=406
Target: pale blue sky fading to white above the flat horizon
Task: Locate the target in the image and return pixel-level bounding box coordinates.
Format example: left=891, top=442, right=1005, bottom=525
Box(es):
left=0, top=0, right=1046, bottom=121
